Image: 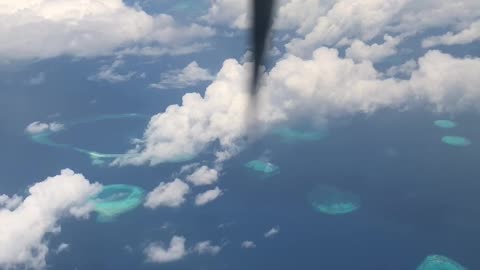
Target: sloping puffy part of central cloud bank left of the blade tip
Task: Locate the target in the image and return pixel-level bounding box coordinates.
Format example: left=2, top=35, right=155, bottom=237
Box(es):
left=110, top=59, right=248, bottom=165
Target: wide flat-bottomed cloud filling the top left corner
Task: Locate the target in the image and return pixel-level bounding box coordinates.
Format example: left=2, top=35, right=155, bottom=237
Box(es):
left=0, top=0, right=215, bottom=59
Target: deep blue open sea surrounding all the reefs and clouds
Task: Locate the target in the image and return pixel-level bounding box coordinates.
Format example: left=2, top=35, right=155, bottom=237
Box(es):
left=0, top=5, right=480, bottom=270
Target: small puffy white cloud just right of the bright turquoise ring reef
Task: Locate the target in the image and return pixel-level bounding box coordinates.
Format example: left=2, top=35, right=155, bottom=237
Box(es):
left=144, top=179, right=190, bottom=208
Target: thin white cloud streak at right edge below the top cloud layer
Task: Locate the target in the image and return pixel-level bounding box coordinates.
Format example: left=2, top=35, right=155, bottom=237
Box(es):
left=422, top=21, right=480, bottom=48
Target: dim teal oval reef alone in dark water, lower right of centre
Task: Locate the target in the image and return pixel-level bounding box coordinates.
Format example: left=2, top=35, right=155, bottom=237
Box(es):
left=307, top=185, right=361, bottom=215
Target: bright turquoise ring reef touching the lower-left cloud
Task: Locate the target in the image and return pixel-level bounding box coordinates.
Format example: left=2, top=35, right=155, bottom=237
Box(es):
left=90, top=184, right=145, bottom=222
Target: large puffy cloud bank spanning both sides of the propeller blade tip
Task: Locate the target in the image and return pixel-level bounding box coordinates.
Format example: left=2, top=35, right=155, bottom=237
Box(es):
left=114, top=48, right=480, bottom=165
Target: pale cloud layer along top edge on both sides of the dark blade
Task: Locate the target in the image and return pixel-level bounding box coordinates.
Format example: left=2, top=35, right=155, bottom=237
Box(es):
left=205, top=0, right=480, bottom=57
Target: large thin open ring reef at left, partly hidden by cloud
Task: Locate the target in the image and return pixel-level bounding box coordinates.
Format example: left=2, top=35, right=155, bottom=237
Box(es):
left=30, top=113, right=149, bottom=166
